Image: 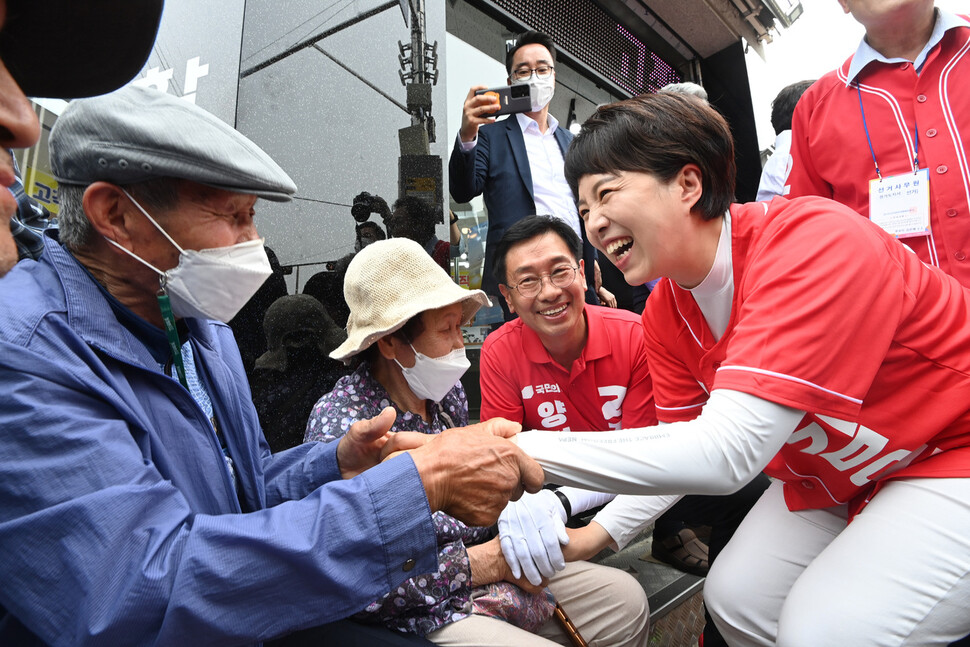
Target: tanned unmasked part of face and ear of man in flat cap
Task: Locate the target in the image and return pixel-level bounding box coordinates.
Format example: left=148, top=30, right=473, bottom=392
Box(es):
left=132, top=181, right=259, bottom=270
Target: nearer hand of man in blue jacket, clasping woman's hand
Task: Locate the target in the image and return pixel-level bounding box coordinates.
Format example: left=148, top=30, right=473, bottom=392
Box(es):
left=410, top=420, right=543, bottom=526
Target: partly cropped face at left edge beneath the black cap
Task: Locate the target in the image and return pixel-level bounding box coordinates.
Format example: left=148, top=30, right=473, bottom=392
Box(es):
left=0, top=0, right=40, bottom=276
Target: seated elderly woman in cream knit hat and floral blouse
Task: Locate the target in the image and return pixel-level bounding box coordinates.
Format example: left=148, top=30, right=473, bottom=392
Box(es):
left=306, top=238, right=646, bottom=647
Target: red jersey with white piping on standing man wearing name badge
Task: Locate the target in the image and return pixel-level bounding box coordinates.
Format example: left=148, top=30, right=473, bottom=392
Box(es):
left=787, top=15, right=970, bottom=287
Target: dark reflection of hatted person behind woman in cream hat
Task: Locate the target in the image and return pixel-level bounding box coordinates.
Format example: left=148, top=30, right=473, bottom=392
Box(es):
left=252, top=294, right=350, bottom=452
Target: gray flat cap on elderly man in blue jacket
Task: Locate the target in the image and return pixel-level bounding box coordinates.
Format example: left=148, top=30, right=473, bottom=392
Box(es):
left=50, top=86, right=296, bottom=202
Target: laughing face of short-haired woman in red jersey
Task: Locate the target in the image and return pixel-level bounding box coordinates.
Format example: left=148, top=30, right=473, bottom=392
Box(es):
left=579, top=171, right=690, bottom=285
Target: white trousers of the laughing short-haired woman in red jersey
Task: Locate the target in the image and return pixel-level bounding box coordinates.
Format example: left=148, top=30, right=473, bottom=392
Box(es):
left=704, top=478, right=970, bottom=647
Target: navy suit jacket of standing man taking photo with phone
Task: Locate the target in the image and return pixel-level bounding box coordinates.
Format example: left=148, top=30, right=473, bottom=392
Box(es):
left=448, top=115, right=598, bottom=304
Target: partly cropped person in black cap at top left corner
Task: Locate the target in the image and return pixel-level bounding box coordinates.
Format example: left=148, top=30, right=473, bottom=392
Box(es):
left=0, top=0, right=162, bottom=277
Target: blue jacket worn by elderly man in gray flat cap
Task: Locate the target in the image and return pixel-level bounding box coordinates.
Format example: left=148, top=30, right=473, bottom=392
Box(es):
left=0, top=238, right=437, bottom=645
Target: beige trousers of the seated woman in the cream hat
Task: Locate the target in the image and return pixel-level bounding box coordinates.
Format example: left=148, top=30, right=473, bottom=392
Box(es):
left=428, top=562, right=650, bottom=647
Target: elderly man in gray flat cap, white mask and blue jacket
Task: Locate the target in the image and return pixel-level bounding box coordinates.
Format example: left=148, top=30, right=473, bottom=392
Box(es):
left=0, top=87, right=542, bottom=645
